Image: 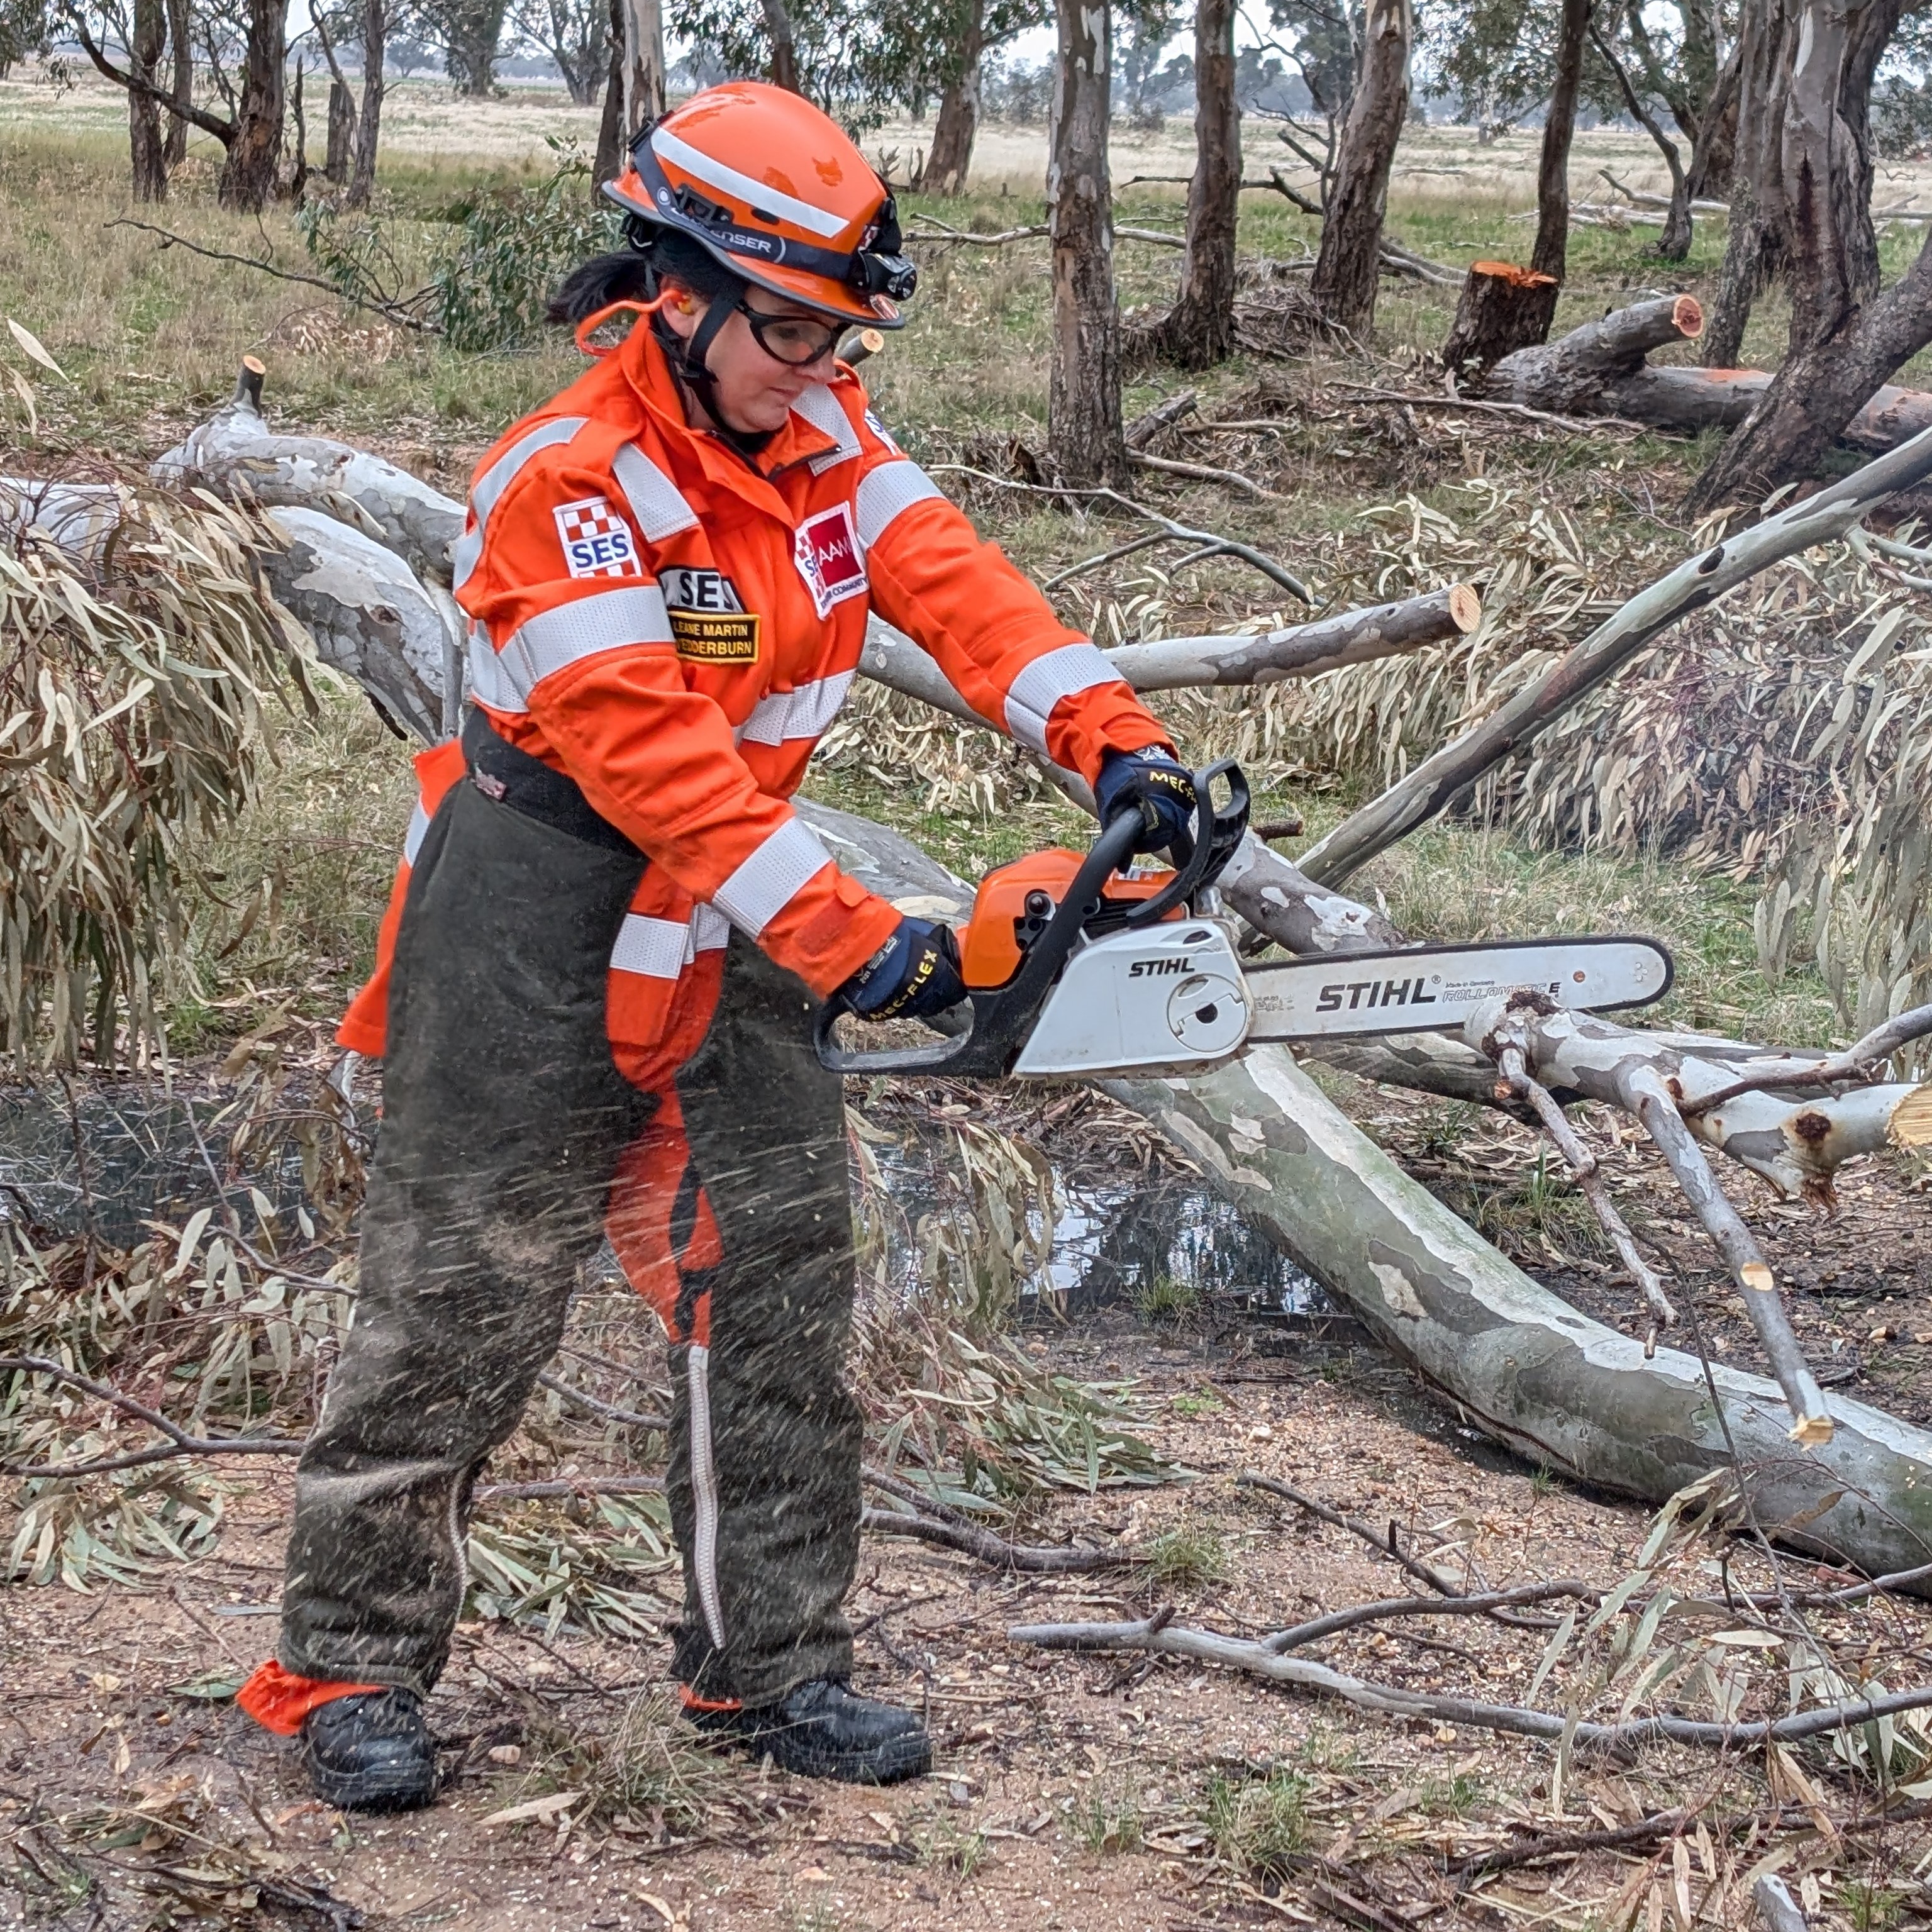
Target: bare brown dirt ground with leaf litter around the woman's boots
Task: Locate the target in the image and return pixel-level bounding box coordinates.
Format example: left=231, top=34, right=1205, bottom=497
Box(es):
left=0, top=1190, right=1932, bottom=1932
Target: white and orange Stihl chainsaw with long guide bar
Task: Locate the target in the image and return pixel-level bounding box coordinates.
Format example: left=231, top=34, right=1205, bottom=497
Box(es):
left=815, top=759, right=1675, bottom=1080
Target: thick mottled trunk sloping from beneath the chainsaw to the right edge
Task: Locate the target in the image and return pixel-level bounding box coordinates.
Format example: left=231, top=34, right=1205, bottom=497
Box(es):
left=1105, top=1047, right=1932, bottom=1588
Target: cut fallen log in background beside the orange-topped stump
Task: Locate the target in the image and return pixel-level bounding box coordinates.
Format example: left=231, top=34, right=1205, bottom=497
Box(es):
left=1476, top=291, right=1932, bottom=454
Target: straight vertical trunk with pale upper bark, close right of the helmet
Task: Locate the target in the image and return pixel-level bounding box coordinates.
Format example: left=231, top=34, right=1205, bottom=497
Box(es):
left=1047, top=0, right=1128, bottom=489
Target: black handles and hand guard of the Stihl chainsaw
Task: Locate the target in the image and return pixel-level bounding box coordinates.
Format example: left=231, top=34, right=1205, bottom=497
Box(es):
left=811, top=757, right=1248, bottom=1080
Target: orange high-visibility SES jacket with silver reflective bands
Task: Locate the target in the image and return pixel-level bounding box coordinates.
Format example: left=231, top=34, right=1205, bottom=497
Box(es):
left=340, top=326, right=1169, bottom=1058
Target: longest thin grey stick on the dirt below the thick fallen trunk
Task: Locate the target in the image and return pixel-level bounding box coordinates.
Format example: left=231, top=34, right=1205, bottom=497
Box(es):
left=1007, top=1619, right=1932, bottom=1750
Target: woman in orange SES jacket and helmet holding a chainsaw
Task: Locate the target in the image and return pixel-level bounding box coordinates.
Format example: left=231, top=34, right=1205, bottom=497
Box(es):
left=242, top=83, right=1192, bottom=1808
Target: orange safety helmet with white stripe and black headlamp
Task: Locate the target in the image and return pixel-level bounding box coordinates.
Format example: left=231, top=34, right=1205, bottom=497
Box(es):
left=605, top=81, right=918, bottom=328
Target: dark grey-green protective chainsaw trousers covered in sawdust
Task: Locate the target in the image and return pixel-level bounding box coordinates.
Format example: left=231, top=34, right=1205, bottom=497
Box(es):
left=278, top=782, right=862, bottom=1704
